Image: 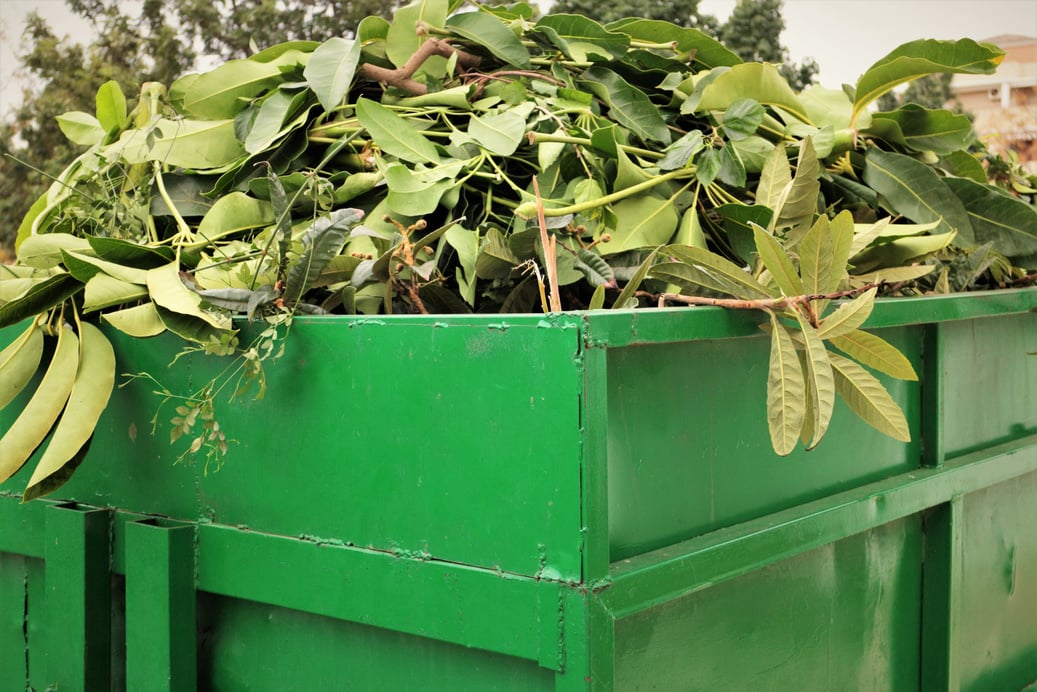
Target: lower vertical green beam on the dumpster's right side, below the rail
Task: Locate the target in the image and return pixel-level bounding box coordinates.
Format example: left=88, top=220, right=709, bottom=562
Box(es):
left=921, top=497, right=964, bottom=692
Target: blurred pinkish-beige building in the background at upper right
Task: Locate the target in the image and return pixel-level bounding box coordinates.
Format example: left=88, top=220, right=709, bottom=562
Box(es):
left=951, top=34, right=1037, bottom=172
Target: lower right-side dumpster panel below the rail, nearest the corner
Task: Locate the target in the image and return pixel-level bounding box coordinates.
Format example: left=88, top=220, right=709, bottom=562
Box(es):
left=615, top=517, right=922, bottom=690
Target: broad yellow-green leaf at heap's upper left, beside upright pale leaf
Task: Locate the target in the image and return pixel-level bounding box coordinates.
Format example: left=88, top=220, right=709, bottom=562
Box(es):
left=183, top=60, right=282, bottom=120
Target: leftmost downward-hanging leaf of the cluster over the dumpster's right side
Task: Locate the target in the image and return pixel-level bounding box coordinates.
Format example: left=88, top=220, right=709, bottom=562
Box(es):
left=767, top=312, right=807, bottom=456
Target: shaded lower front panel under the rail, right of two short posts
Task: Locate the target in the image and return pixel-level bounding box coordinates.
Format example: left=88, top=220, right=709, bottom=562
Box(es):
left=191, top=594, right=555, bottom=692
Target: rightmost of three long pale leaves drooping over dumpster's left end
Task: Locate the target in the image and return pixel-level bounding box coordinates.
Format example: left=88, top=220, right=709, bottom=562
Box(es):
left=22, top=322, right=115, bottom=501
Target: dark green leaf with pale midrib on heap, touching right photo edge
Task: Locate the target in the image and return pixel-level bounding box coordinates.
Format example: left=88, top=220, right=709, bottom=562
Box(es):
left=944, top=177, right=1037, bottom=257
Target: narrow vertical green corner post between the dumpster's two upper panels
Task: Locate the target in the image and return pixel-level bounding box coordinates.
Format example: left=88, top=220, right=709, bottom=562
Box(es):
left=580, top=345, right=611, bottom=584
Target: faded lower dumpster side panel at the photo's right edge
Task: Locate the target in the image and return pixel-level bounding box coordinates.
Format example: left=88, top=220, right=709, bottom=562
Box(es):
left=958, top=473, right=1037, bottom=692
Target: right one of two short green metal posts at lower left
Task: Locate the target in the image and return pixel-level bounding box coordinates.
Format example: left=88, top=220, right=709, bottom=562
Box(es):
left=125, top=519, right=198, bottom=692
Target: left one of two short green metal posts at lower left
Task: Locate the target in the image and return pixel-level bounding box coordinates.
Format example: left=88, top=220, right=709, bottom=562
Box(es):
left=44, top=503, right=112, bottom=692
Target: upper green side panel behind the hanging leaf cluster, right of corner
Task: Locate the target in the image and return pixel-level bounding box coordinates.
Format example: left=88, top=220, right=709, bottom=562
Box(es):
left=608, top=328, right=922, bottom=560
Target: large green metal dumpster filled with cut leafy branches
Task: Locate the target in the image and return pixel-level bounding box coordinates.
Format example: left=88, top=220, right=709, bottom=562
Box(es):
left=0, top=289, right=1037, bottom=691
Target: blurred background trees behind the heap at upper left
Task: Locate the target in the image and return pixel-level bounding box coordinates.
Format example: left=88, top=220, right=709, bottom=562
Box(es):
left=0, top=0, right=393, bottom=254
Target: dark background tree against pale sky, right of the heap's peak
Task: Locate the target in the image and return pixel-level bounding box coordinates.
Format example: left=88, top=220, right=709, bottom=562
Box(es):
left=717, top=0, right=818, bottom=89
